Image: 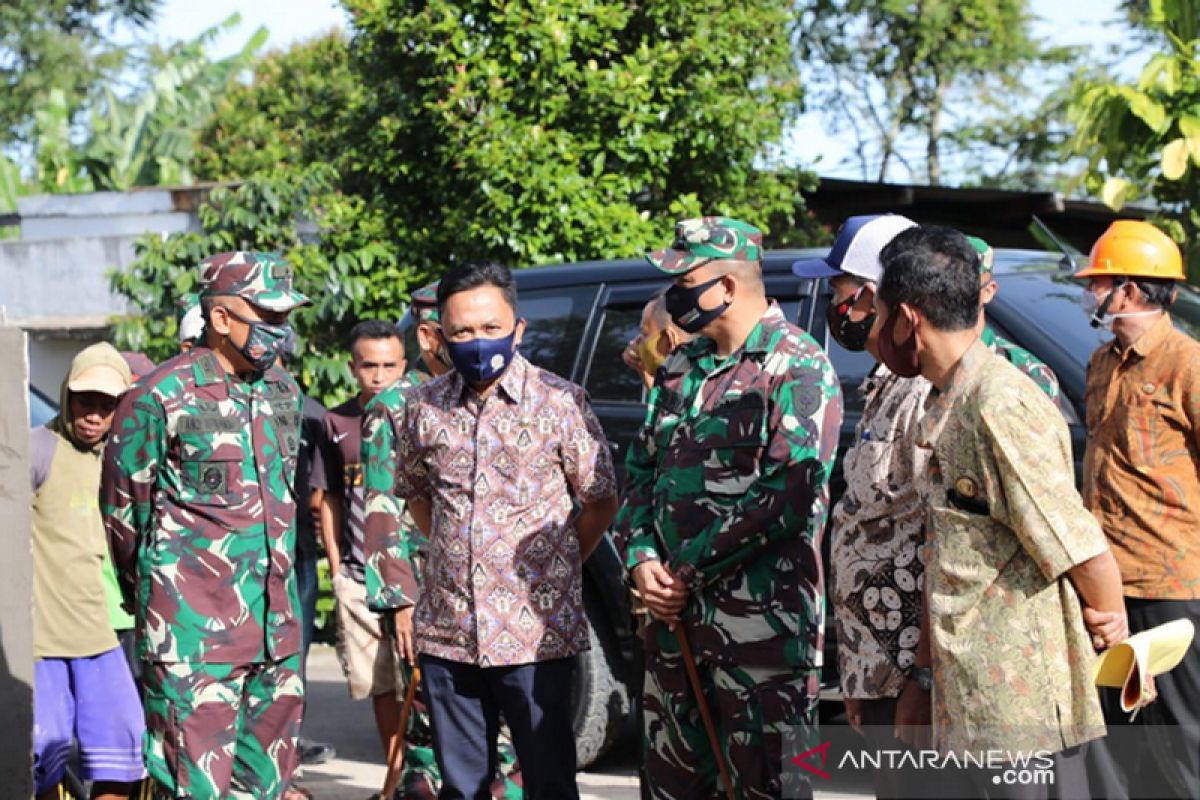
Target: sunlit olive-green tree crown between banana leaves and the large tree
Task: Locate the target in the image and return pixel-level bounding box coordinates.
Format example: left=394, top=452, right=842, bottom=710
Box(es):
left=193, top=31, right=359, bottom=180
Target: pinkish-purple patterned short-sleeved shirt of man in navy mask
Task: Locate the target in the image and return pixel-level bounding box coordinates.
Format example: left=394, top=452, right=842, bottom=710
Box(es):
left=396, top=354, right=616, bottom=667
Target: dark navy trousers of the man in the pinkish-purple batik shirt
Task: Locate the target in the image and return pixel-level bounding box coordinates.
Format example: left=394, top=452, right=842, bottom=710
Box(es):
left=420, top=655, right=580, bottom=800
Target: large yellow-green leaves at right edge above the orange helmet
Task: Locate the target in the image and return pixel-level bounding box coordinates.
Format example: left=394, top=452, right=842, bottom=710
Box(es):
left=1070, top=0, right=1200, bottom=281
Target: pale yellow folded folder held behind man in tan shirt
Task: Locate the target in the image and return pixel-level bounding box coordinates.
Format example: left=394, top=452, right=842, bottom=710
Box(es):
left=1092, top=618, right=1195, bottom=712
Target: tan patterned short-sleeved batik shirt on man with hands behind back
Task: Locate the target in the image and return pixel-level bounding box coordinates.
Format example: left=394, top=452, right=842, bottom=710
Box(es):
left=917, top=342, right=1108, bottom=753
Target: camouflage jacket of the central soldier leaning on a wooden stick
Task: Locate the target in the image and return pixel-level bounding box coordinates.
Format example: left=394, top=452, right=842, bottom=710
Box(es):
left=614, top=303, right=842, bottom=667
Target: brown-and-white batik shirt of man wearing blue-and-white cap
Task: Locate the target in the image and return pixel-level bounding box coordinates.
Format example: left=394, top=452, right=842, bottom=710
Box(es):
left=830, top=365, right=932, bottom=698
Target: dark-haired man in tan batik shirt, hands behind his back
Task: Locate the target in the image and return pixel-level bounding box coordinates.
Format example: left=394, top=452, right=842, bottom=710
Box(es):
left=875, top=225, right=1128, bottom=798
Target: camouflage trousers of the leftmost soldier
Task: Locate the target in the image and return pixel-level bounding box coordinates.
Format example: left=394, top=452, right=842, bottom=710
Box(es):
left=143, top=655, right=304, bottom=800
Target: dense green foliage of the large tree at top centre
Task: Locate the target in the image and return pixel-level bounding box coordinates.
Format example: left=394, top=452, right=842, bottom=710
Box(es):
left=338, top=0, right=805, bottom=275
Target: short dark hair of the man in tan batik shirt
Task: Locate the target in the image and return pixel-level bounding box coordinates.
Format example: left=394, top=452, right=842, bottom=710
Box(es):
left=880, top=225, right=979, bottom=331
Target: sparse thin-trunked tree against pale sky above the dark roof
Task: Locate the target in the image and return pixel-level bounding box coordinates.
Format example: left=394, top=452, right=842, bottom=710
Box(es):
left=799, top=0, right=1079, bottom=188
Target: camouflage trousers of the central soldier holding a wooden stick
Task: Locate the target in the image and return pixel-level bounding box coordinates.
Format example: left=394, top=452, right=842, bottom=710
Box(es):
left=642, top=621, right=820, bottom=800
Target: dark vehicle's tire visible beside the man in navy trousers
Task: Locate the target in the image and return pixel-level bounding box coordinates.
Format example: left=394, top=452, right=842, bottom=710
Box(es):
left=571, top=589, right=630, bottom=770
